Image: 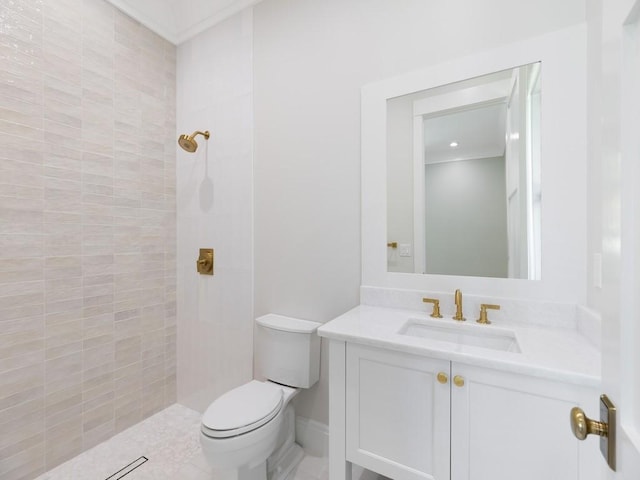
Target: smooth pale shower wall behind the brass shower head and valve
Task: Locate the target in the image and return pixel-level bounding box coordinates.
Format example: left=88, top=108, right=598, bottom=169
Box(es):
left=177, top=9, right=253, bottom=411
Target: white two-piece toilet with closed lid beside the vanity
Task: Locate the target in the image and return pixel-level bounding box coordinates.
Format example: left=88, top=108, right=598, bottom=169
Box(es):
left=200, top=314, right=320, bottom=480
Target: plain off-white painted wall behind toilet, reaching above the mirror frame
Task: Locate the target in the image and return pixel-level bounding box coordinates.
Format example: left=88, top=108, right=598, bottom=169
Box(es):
left=254, top=0, right=585, bottom=423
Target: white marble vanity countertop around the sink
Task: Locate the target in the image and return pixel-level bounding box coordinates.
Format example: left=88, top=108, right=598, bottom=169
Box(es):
left=318, top=305, right=600, bottom=387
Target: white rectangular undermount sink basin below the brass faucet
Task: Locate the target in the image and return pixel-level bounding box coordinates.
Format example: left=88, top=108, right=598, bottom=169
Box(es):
left=398, top=318, right=521, bottom=353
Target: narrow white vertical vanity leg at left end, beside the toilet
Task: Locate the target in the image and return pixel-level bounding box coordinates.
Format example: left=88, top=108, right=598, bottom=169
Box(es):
left=329, top=340, right=351, bottom=480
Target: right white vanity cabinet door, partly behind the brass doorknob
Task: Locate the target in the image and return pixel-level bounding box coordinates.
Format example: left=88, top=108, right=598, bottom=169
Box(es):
left=451, top=362, right=601, bottom=480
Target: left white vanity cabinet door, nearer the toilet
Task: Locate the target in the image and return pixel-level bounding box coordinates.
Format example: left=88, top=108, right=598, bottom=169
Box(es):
left=346, top=344, right=450, bottom=480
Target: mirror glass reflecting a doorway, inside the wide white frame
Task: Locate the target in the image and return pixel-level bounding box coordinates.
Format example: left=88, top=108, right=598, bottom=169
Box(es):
left=387, top=63, right=541, bottom=280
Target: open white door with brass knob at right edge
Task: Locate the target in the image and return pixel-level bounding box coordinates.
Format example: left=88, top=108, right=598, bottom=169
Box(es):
left=587, top=0, right=640, bottom=480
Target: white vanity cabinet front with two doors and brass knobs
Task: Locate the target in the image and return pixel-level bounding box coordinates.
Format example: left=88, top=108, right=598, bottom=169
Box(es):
left=342, top=342, right=601, bottom=480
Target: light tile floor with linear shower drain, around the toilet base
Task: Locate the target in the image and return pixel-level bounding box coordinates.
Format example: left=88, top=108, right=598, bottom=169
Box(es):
left=36, top=404, right=382, bottom=480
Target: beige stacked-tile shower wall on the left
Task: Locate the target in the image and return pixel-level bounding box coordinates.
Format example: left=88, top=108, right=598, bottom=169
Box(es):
left=0, top=0, right=176, bottom=480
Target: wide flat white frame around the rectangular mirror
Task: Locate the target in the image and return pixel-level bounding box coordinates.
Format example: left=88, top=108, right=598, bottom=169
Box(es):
left=361, top=25, right=587, bottom=304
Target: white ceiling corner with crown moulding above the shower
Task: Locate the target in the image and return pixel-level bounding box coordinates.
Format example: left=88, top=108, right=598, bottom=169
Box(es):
left=107, top=0, right=261, bottom=45
